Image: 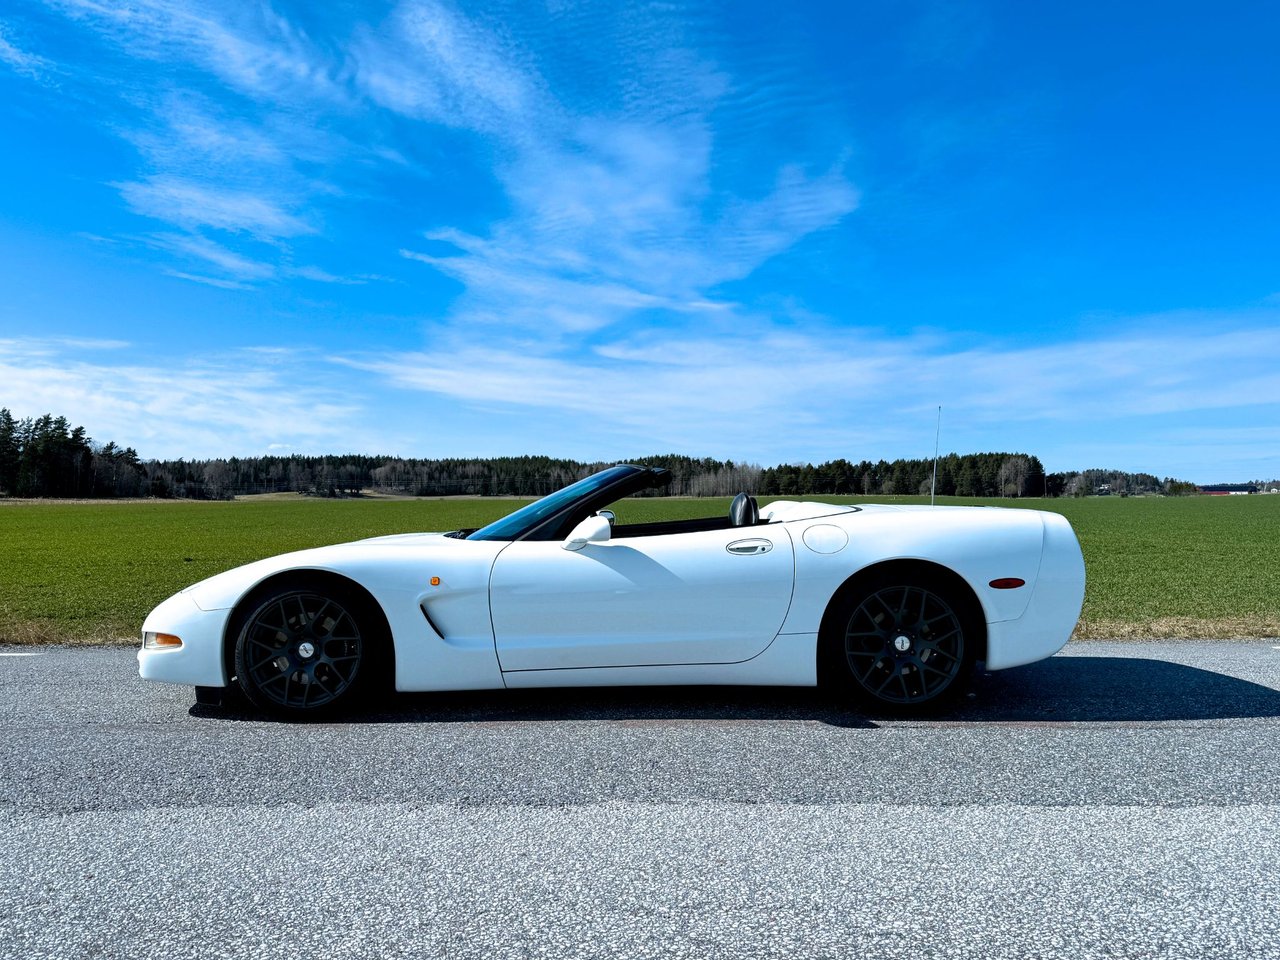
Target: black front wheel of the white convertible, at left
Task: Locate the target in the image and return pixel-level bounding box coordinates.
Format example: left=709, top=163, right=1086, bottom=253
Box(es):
left=236, top=586, right=380, bottom=717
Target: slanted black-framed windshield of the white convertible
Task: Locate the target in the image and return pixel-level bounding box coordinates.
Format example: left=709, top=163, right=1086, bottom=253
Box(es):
left=466, top=463, right=671, bottom=540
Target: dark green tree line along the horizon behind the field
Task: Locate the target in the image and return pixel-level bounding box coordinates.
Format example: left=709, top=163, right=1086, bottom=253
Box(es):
left=0, top=408, right=1218, bottom=500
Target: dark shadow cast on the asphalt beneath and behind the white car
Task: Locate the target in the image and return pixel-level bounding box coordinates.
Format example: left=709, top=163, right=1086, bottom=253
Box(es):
left=191, top=657, right=1280, bottom=728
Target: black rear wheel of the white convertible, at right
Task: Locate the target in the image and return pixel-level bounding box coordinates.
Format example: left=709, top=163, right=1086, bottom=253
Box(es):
left=827, top=577, right=977, bottom=713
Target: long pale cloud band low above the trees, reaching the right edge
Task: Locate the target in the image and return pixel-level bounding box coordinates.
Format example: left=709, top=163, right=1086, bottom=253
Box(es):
left=335, top=315, right=1280, bottom=470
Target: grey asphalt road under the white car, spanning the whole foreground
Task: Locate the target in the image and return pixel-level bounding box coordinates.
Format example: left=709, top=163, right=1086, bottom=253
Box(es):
left=0, top=641, right=1280, bottom=960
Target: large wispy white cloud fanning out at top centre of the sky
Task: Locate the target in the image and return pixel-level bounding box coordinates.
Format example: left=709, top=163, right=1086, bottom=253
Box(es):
left=378, top=4, right=858, bottom=334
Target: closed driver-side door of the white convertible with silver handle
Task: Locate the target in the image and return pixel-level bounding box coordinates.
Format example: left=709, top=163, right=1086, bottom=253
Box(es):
left=489, top=524, right=795, bottom=671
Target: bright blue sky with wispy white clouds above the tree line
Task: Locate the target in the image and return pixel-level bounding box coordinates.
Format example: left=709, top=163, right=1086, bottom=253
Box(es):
left=0, top=0, right=1280, bottom=483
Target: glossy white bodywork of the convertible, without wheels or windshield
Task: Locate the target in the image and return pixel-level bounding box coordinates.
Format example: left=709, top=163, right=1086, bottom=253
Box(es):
left=138, top=500, right=1084, bottom=690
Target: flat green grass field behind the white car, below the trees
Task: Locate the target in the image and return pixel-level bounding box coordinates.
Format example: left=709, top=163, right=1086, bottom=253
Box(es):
left=0, top=497, right=1280, bottom=643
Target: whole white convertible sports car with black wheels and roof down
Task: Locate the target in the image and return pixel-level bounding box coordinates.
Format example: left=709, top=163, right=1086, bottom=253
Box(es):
left=138, top=465, right=1084, bottom=717
